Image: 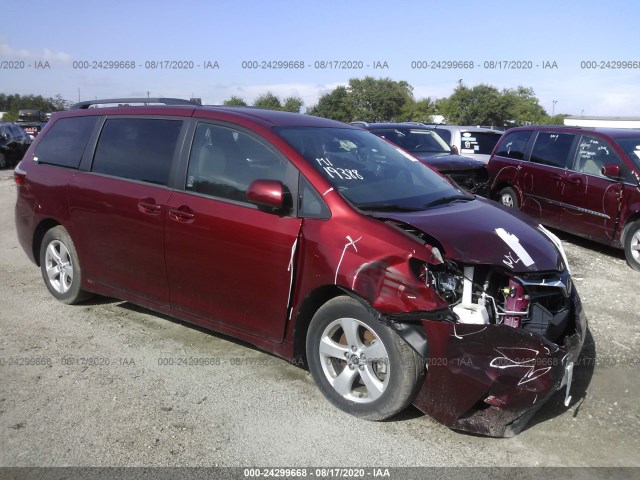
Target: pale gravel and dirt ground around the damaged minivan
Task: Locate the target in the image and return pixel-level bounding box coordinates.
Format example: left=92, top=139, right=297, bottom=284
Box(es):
left=0, top=170, right=640, bottom=467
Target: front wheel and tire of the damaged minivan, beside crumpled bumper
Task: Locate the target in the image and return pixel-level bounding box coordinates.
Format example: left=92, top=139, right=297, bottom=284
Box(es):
left=306, top=296, right=424, bottom=420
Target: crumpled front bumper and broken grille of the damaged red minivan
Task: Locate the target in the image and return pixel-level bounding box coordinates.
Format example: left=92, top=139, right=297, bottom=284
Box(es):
left=414, top=274, right=587, bottom=437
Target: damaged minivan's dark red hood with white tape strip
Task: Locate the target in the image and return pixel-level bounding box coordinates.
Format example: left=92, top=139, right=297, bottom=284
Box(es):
left=384, top=198, right=565, bottom=273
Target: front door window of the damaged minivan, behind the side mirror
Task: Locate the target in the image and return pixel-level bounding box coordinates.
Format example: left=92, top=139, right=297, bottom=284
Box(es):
left=185, top=123, right=287, bottom=202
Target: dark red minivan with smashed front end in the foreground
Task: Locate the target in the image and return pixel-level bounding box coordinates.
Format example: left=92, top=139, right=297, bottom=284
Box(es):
left=15, top=99, right=587, bottom=436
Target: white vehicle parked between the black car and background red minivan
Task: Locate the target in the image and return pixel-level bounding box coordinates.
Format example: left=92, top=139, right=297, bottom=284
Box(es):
left=426, top=125, right=503, bottom=163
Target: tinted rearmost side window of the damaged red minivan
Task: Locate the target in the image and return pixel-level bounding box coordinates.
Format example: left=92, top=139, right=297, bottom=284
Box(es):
left=34, top=115, right=100, bottom=168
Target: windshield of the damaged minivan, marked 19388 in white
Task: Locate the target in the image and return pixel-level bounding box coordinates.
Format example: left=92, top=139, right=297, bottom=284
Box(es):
left=278, top=127, right=464, bottom=211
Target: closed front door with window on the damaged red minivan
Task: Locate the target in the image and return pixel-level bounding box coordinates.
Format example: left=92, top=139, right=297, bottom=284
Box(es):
left=165, top=123, right=301, bottom=342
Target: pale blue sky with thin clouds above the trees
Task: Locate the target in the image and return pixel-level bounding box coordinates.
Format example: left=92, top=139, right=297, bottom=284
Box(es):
left=0, top=0, right=640, bottom=117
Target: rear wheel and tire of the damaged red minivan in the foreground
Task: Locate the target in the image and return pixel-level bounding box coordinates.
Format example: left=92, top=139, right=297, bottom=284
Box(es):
left=40, top=225, right=91, bottom=305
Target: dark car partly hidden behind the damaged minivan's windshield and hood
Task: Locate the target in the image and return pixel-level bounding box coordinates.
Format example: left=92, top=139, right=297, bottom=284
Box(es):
left=351, top=122, right=489, bottom=195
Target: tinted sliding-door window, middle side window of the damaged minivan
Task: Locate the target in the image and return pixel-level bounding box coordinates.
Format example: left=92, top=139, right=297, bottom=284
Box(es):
left=91, top=118, right=182, bottom=185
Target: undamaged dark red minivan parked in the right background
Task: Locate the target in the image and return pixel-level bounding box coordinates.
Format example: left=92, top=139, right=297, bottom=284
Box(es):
left=488, top=126, right=640, bottom=270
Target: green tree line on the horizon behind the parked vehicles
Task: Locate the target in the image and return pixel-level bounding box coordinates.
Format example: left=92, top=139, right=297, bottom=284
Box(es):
left=0, top=76, right=567, bottom=128
